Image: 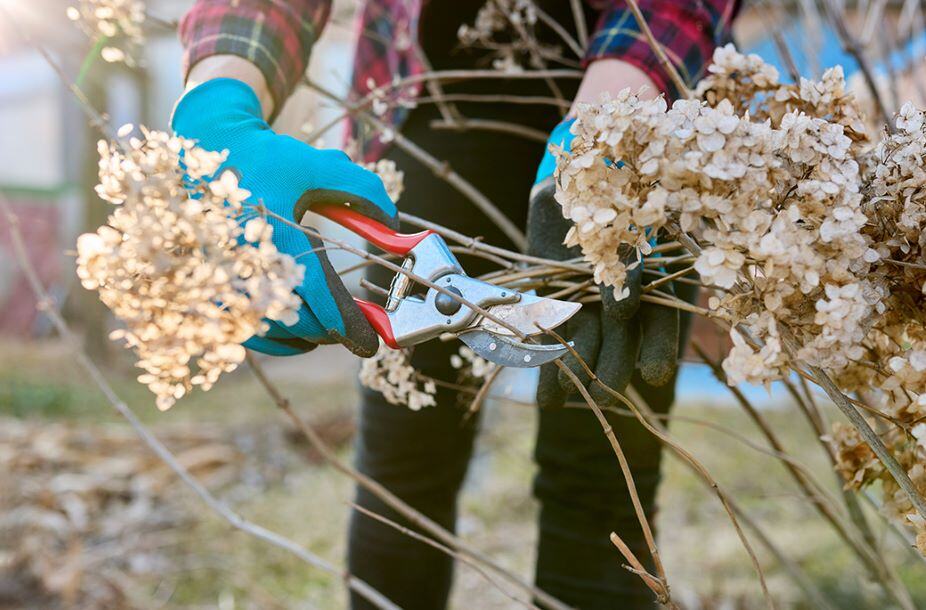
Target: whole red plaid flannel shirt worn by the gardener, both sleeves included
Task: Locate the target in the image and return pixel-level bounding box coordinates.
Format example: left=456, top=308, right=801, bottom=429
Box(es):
left=180, top=0, right=739, bottom=161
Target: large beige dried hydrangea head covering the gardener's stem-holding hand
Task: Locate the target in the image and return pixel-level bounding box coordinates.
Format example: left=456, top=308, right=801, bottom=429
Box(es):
left=557, top=47, right=882, bottom=383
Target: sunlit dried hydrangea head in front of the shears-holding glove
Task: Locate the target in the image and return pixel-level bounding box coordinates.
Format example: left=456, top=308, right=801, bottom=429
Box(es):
left=77, top=127, right=303, bottom=409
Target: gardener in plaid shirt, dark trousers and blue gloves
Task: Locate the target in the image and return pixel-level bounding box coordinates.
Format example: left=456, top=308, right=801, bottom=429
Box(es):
left=172, top=0, right=736, bottom=610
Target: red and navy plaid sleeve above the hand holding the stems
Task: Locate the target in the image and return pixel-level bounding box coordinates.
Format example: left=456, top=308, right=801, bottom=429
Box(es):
left=584, top=0, right=740, bottom=100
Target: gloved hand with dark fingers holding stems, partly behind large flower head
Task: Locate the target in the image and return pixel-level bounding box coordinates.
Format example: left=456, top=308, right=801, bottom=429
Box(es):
left=527, top=119, right=679, bottom=407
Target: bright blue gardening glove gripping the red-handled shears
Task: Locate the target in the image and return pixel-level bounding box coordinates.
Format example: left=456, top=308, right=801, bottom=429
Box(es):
left=171, top=78, right=397, bottom=356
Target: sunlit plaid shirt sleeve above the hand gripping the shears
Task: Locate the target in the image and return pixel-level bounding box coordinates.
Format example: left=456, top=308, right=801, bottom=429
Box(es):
left=179, top=0, right=331, bottom=114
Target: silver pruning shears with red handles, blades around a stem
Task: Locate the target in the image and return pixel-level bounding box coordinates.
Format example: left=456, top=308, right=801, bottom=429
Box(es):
left=312, top=205, right=581, bottom=368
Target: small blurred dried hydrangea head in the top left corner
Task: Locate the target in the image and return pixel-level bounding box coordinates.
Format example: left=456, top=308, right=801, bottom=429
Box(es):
left=67, top=0, right=145, bottom=65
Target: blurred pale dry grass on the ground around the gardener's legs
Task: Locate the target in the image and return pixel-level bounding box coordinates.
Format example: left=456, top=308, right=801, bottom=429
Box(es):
left=0, top=343, right=926, bottom=609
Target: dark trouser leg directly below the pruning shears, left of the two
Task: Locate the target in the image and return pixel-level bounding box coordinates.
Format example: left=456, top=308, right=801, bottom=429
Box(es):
left=348, top=356, right=476, bottom=610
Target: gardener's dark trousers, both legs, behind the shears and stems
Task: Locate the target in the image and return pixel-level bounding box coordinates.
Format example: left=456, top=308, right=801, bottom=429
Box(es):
left=349, top=94, right=688, bottom=610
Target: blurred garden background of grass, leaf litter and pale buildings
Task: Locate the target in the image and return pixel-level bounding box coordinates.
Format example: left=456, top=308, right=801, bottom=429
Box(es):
left=0, top=0, right=926, bottom=610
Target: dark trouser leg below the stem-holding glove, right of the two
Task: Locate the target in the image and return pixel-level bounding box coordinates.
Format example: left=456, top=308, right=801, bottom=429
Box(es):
left=534, top=286, right=694, bottom=610
